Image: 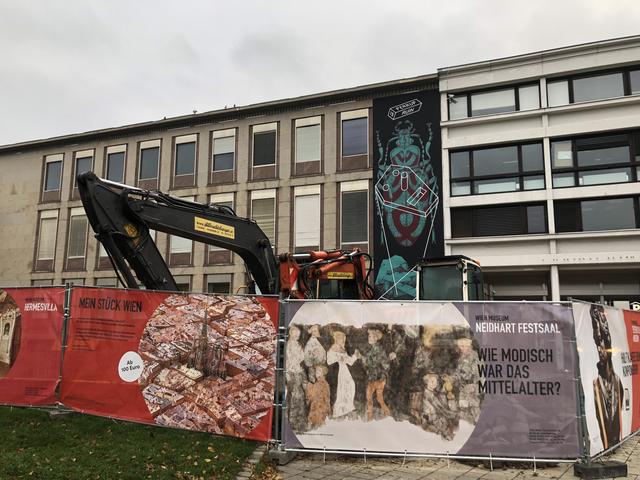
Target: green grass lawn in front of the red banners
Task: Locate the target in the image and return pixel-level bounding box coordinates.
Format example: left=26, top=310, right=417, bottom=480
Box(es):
left=0, top=407, right=256, bottom=480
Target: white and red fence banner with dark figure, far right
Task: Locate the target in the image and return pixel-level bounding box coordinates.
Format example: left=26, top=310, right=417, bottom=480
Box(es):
left=573, top=303, right=640, bottom=456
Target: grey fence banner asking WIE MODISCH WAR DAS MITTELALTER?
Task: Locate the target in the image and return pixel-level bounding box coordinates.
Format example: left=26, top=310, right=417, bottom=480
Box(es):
left=283, top=301, right=579, bottom=458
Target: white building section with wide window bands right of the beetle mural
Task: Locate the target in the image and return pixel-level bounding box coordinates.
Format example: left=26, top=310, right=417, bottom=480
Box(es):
left=439, top=37, right=640, bottom=302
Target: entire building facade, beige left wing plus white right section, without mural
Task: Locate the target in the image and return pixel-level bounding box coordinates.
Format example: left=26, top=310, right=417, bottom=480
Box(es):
left=0, top=33, right=640, bottom=302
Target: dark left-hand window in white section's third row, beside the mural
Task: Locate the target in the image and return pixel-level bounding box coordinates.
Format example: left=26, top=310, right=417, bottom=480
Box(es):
left=451, top=203, right=547, bottom=238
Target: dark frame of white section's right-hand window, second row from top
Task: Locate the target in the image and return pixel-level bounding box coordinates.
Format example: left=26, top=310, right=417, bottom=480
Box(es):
left=549, top=130, right=640, bottom=189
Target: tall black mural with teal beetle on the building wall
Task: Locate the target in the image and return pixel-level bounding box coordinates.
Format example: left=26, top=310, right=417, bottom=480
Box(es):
left=373, top=90, right=444, bottom=299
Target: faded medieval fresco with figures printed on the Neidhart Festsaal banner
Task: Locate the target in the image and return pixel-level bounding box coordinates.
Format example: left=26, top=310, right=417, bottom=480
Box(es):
left=286, top=316, right=482, bottom=441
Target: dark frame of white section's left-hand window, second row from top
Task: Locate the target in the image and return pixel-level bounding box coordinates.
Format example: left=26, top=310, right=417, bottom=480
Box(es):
left=449, top=139, right=547, bottom=197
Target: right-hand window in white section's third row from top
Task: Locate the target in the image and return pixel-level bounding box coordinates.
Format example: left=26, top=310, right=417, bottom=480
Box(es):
left=554, top=197, right=638, bottom=233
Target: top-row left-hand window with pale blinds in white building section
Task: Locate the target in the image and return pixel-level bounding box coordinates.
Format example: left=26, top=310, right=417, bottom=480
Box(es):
left=447, top=83, right=540, bottom=120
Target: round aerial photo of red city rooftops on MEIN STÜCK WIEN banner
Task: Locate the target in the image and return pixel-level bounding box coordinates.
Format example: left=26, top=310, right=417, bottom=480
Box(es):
left=138, top=294, right=274, bottom=437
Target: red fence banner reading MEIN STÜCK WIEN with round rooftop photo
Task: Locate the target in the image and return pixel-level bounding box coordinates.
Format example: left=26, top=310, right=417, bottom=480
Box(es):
left=61, top=288, right=278, bottom=440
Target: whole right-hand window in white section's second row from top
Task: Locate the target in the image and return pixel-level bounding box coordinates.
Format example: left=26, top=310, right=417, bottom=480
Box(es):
left=551, top=132, right=640, bottom=188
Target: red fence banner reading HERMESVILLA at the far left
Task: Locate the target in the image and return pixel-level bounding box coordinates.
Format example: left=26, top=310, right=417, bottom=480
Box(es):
left=0, top=287, right=64, bottom=405
